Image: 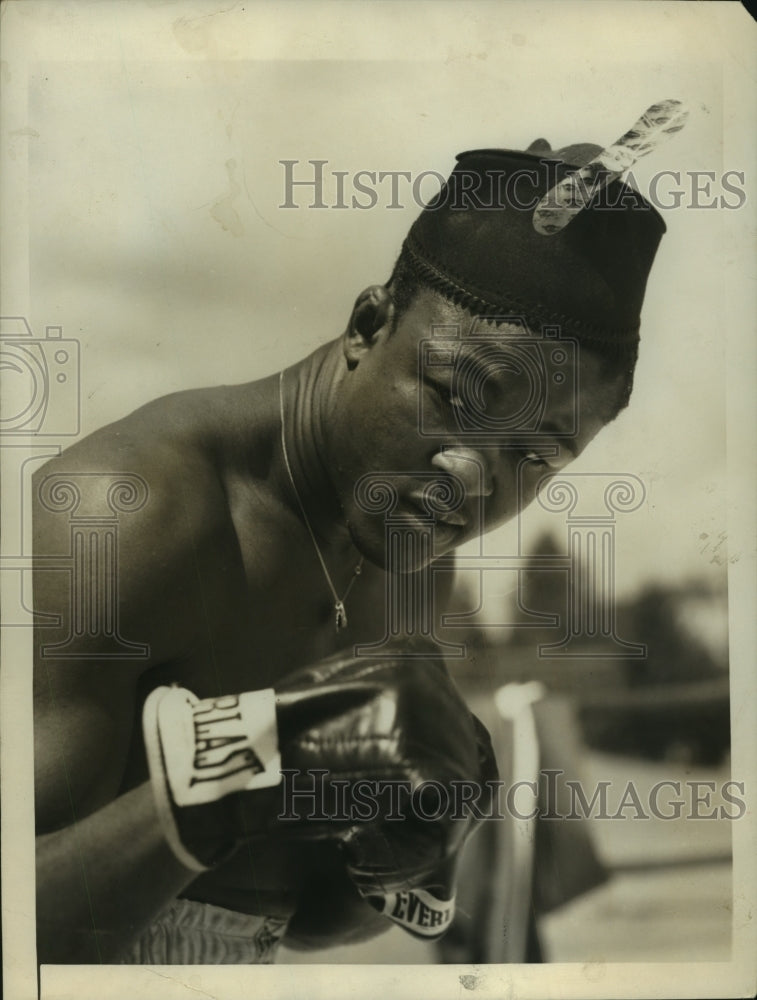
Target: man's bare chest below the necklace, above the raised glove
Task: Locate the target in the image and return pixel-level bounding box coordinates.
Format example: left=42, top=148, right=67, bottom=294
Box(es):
left=172, top=500, right=389, bottom=695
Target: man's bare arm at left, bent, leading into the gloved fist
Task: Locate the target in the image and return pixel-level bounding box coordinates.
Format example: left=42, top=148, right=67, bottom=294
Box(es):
left=34, top=426, right=226, bottom=963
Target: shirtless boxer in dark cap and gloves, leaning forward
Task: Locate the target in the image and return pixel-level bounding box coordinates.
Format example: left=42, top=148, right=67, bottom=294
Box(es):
left=34, top=137, right=664, bottom=963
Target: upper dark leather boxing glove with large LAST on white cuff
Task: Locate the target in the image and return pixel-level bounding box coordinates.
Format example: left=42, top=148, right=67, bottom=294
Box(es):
left=144, top=656, right=496, bottom=930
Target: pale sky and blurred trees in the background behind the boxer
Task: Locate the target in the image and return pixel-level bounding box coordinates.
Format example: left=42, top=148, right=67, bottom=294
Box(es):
left=11, top=3, right=741, bottom=962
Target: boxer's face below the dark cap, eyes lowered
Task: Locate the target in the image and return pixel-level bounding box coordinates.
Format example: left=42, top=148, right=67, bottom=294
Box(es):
left=327, top=290, right=622, bottom=571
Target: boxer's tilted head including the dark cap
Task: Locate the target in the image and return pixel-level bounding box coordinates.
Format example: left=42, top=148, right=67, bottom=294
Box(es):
left=329, top=144, right=664, bottom=564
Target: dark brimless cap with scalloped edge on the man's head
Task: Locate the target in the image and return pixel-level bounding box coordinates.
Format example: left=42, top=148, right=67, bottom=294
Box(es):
left=405, top=140, right=665, bottom=355
